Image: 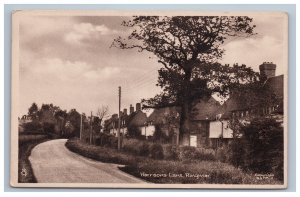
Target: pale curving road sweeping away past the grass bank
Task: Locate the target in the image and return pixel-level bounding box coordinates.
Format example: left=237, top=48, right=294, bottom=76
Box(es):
left=29, top=139, right=142, bottom=183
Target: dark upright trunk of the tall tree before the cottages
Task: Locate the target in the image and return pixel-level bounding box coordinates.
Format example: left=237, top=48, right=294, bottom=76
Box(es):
left=179, top=71, right=192, bottom=145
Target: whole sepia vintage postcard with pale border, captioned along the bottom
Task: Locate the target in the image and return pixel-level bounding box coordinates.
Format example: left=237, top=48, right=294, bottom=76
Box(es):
left=11, top=10, right=288, bottom=189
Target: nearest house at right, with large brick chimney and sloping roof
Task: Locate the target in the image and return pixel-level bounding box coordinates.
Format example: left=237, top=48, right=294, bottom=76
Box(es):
left=209, top=62, right=284, bottom=147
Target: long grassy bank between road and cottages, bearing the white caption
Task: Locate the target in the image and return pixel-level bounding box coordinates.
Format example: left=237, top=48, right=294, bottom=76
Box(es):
left=66, top=139, right=282, bottom=185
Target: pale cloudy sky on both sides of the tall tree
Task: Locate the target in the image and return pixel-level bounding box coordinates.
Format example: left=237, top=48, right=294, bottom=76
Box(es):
left=19, top=15, right=287, bottom=116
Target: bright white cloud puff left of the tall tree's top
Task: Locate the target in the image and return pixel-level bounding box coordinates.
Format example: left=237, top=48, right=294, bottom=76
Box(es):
left=64, top=23, right=119, bottom=44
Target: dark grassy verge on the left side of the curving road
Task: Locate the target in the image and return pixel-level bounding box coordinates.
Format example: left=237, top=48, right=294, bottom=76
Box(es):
left=18, top=134, right=49, bottom=183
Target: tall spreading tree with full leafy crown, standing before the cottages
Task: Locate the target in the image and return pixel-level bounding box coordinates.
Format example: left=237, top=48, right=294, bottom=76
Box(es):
left=113, top=16, right=257, bottom=144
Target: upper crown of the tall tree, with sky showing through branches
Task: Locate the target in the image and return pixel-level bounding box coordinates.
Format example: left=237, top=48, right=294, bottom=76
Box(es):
left=113, top=16, right=255, bottom=67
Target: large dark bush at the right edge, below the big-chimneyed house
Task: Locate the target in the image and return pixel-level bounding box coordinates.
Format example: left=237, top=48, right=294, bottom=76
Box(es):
left=230, top=118, right=284, bottom=180
